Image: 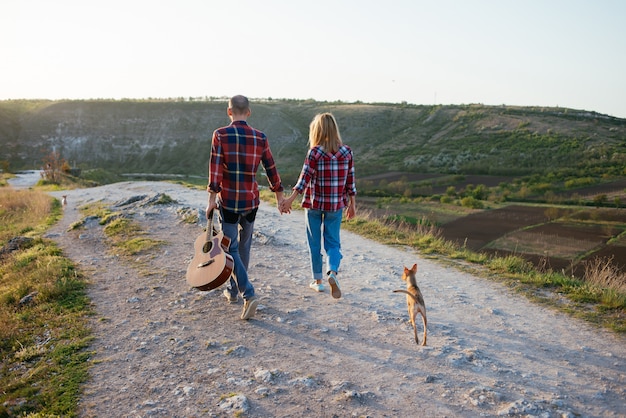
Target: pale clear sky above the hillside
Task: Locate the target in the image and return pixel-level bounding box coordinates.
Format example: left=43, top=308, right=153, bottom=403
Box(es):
left=0, top=0, right=626, bottom=118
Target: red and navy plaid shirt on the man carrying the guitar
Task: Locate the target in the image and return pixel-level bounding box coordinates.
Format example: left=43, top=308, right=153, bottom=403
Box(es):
left=207, top=120, right=283, bottom=213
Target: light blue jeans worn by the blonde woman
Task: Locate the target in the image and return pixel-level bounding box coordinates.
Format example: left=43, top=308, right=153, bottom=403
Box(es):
left=305, top=209, right=343, bottom=280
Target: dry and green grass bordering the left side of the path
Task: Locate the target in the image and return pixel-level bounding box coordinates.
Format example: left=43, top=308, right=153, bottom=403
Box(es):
left=0, top=188, right=92, bottom=417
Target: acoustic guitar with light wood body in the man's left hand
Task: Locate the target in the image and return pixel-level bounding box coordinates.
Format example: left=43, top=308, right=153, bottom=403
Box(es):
left=187, top=211, right=235, bottom=290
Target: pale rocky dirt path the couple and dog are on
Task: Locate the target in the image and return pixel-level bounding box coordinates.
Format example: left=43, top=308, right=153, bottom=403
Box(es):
left=39, top=182, right=626, bottom=417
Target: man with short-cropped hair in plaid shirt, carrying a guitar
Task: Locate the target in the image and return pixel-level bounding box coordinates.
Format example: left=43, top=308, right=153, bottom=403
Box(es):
left=206, top=95, right=283, bottom=320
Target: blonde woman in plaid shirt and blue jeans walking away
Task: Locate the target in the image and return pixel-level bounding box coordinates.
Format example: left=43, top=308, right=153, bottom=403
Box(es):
left=281, top=113, right=356, bottom=299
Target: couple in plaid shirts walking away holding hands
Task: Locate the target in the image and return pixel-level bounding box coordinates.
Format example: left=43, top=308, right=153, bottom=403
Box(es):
left=206, top=95, right=356, bottom=320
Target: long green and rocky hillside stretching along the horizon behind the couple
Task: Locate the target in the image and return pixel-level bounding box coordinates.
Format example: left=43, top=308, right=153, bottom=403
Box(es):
left=0, top=100, right=626, bottom=184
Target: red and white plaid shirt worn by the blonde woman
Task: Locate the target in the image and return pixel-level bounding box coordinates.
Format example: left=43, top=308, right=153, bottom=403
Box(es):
left=293, top=145, right=356, bottom=212
